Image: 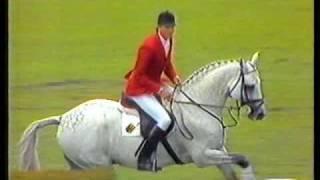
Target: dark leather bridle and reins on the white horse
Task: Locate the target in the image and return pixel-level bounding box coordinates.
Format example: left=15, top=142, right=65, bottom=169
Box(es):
left=169, top=59, right=264, bottom=140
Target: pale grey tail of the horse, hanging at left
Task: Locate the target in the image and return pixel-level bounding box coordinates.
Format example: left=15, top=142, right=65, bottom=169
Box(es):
left=19, top=116, right=60, bottom=171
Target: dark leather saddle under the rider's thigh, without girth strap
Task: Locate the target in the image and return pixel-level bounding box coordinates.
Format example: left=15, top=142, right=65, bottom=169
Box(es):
left=120, top=93, right=175, bottom=138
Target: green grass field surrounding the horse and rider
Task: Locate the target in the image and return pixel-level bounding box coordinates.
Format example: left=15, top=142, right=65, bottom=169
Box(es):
left=9, top=0, right=313, bottom=180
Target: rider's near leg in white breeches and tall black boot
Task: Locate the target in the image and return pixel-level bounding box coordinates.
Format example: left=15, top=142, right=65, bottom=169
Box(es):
left=130, top=95, right=171, bottom=171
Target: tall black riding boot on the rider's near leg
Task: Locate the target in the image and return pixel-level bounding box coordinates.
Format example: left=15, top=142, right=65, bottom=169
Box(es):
left=138, top=126, right=165, bottom=171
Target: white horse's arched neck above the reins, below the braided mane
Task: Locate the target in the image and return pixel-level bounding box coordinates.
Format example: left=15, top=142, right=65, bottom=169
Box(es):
left=179, top=62, right=239, bottom=116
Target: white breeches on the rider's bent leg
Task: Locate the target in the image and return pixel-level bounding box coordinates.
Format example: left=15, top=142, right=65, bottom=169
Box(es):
left=129, top=94, right=171, bottom=131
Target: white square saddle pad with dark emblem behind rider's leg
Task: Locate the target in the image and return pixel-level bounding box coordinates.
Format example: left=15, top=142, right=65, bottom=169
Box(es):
left=121, top=111, right=141, bottom=136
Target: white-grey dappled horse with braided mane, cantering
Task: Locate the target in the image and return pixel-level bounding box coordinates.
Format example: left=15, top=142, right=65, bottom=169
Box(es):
left=20, top=53, right=266, bottom=179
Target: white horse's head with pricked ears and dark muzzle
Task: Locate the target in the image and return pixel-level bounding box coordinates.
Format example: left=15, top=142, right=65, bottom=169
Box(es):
left=229, top=52, right=267, bottom=120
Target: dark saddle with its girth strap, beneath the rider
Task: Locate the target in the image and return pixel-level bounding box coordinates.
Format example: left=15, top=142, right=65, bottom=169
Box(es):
left=120, top=92, right=183, bottom=164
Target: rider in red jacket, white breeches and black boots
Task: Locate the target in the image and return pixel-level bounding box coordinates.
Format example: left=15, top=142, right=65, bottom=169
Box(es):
left=124, top=11, right=181, bottom=171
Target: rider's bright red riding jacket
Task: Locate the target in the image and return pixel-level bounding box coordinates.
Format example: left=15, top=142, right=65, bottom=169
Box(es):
left=125, top=33, right=177, bottom=96
